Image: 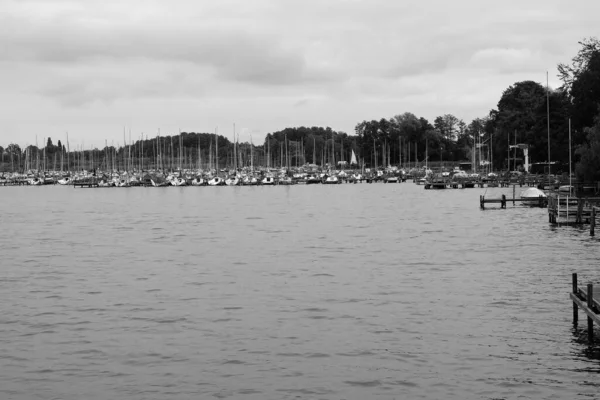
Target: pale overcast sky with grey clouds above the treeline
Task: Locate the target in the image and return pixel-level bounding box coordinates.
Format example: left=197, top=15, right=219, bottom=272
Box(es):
left=0, top=0, right=600, bottom=148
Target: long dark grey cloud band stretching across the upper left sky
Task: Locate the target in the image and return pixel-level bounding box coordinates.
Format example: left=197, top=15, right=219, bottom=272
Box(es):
left=0, top=21, right=319, bottom=84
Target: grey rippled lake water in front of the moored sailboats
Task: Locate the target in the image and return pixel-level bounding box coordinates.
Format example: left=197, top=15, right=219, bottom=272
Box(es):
left=0, top=183, right=600, bottom=400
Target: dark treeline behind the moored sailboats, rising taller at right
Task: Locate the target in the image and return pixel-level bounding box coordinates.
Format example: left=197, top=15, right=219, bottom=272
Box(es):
left=0, top=38, right=600, bottom=180
